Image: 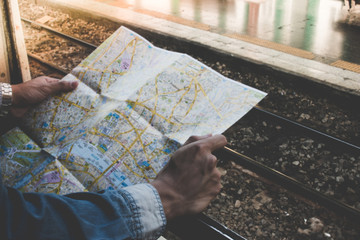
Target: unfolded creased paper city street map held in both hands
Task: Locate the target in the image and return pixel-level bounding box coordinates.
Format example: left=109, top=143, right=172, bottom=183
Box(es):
left=0, top=27, right=266, bottom=194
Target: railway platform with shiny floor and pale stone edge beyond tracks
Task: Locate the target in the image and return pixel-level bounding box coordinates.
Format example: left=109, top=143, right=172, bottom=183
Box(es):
left=40, top=0, right=360, bottom=95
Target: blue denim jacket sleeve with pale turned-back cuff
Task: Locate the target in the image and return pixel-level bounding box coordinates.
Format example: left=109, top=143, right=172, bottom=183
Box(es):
left=0, top=171, right=166, bottom=240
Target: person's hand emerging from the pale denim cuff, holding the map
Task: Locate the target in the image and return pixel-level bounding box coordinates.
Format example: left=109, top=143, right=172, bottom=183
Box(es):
left=151, top=135, right=227, bottom=220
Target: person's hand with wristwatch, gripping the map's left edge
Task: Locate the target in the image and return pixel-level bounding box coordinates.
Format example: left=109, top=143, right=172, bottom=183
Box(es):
left=11, top=76, right=79, bottom=117
